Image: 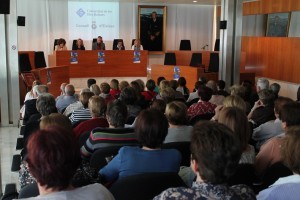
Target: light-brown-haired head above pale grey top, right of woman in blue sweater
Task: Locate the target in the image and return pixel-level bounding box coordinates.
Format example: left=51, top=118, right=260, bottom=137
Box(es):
left=165, top=101, right=187, bottom=125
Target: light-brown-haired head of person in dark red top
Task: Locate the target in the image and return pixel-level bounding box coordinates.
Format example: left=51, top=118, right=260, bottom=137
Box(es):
left=89, top=96, right=106, bottom=117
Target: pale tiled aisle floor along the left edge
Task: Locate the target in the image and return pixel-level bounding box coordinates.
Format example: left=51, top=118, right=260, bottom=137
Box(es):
left=0, top=127, right=20, bottom=192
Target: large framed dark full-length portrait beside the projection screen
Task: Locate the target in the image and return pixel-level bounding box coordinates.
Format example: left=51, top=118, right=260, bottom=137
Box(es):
left=138, top=6, right=167, bottom=53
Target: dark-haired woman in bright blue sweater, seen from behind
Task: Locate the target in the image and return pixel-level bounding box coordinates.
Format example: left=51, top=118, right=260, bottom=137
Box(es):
left=99, top=109, right=181, bottom=182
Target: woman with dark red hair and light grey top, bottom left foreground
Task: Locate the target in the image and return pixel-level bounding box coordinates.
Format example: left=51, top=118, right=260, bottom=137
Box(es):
left=18, top=126, right=114, bottom=200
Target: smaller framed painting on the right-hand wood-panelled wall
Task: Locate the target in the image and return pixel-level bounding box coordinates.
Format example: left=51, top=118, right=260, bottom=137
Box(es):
left=266, top=13, right=290, bottom=37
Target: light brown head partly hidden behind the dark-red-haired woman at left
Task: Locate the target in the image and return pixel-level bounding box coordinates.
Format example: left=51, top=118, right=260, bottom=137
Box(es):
left=40, top=113, right=73, bottom=131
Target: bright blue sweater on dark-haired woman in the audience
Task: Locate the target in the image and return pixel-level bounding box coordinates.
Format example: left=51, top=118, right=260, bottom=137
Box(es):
left=99, top=147, right=181, bottom=182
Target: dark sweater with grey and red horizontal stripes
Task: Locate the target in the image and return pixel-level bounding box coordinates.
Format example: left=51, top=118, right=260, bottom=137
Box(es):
left=81, top=128, right=138, bottom=158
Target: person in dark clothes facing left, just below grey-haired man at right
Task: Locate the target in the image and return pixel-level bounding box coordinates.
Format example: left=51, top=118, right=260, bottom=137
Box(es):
left=248, top=89, right=275, bottom=127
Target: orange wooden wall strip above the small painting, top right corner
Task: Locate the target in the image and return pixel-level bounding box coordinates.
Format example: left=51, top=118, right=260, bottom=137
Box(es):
left=243, top=0, right=300, bottom=15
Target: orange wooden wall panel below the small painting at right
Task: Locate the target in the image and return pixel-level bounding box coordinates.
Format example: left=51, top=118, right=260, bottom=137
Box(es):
left=242, top=37, right=300, bottom=83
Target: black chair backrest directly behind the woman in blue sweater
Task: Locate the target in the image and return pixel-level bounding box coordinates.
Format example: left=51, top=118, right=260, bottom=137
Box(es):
left=110, top=173, right=186, bottom=200
